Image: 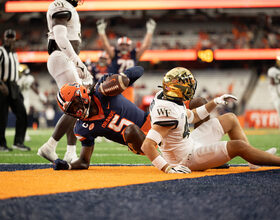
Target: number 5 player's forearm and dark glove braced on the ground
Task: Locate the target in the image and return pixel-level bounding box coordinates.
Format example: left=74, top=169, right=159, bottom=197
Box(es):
left=53, top=146, right=94, bottom=170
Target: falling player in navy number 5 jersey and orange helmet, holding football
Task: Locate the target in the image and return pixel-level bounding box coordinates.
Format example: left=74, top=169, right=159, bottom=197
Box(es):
left=53, top=66, right=150, bottom=170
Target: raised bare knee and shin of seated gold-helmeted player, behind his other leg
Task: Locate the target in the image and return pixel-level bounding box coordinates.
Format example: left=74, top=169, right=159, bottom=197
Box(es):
left=218, top=113, right=249, bottom=143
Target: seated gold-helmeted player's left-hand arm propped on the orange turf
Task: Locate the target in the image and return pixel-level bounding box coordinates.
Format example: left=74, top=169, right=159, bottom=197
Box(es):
left=141, top=125, right=191, bottom=173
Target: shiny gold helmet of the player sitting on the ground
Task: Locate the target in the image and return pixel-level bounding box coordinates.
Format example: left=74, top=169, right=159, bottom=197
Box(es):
left=162, top=67, right=197, bottom=101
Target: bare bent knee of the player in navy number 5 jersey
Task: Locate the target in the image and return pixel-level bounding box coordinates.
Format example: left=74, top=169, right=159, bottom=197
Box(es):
left=124, top=124, right=146, bottom=155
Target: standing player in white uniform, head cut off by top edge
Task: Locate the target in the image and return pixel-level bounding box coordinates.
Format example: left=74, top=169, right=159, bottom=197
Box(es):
left=38, top=0, right=92, bottom=162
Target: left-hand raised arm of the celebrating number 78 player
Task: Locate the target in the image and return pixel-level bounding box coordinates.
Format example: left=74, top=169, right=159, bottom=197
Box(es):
left=96, top=19, right=115, bottom=59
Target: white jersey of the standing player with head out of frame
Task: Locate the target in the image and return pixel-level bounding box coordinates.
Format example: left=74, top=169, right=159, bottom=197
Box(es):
left=47, top=0, right=81, bottom=42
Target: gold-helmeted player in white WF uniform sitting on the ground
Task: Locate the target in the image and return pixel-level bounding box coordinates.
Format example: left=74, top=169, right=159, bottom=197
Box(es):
left=141, top=67, right=280, bottom=173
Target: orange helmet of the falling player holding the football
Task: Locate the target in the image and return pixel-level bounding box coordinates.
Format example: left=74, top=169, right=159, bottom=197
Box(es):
left=56, top=83, right=91, bottom=119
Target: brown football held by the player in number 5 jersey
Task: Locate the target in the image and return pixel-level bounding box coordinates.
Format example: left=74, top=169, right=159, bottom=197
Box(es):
left=98, top=74, right=129, bottom=96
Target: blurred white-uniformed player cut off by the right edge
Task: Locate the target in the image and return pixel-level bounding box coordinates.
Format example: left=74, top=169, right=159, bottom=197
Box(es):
left=267, top=56, right=280, bottom=128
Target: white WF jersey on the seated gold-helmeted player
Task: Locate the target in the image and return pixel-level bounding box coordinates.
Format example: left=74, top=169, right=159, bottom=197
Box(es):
left=150, top=91, right=194, bottom=164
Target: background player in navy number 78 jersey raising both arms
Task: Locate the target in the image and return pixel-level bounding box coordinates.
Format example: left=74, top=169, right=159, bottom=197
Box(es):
left=96, top=19, right=156, bottom=102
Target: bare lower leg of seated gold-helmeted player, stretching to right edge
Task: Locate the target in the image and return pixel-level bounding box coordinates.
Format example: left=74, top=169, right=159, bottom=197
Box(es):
left=227, top=140, right=280, bottom=166
